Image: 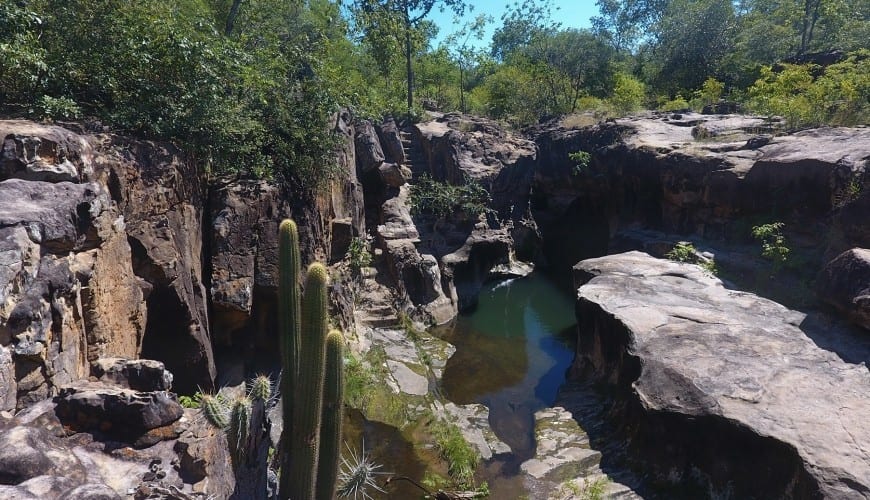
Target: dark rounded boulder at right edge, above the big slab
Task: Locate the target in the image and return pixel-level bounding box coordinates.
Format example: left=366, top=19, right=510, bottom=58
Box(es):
left=816, top=248, right=870, bottom=330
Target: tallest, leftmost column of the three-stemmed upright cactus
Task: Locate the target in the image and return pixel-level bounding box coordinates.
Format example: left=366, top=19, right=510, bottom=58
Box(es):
left=278, top=219, right=301, bottom=498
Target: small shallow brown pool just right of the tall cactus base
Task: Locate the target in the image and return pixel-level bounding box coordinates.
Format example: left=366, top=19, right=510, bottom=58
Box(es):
left=342, top=409, right=426, bottom=499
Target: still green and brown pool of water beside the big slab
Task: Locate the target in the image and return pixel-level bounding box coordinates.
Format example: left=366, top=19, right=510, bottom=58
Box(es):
left=443, top=276, right=575, bottom=456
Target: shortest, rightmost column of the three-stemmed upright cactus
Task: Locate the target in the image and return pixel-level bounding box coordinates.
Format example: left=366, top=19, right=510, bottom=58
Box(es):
left=316, top=330, right=344, bottom=500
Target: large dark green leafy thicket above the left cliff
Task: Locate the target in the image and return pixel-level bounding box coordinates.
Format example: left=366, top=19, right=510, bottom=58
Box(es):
left=0, top=0, right=344, bottom=187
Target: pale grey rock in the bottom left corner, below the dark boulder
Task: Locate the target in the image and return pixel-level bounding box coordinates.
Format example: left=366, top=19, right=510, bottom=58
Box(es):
left=0, top=394, right=235, bottom=500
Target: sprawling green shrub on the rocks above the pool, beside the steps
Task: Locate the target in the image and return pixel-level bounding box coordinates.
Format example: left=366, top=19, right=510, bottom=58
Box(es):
left=411, top=175, right=490, bottom=222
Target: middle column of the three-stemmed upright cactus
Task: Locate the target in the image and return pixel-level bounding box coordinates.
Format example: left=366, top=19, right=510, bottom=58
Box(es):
left=290, top=263, right=328, bottom=500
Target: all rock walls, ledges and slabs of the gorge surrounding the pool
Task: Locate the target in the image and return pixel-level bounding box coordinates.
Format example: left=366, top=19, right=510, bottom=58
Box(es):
left=0, top=113, right=870, bottom=498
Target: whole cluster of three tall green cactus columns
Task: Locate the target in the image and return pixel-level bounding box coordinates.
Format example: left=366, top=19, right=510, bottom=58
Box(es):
left=278, top=220, right=344, bottom=500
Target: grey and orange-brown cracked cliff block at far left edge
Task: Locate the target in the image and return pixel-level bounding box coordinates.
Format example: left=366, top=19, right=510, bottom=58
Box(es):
left=0, top=179, right=146, bottom=410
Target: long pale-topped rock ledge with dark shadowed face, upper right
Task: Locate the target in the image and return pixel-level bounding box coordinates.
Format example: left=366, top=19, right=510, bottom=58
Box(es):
left=532, top=113, right=870, bottom=267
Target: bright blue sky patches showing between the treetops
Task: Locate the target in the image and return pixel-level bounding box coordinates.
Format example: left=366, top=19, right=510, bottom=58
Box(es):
left=429, top=0, right=598, bottom=46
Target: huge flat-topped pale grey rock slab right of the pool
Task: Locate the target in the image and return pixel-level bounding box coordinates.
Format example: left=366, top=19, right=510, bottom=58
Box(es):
left=573, top=252, right=870, bottom=498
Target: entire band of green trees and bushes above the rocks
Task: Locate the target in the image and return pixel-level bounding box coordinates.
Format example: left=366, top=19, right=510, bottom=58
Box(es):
left=0, top=0, right=870, bottom=181
